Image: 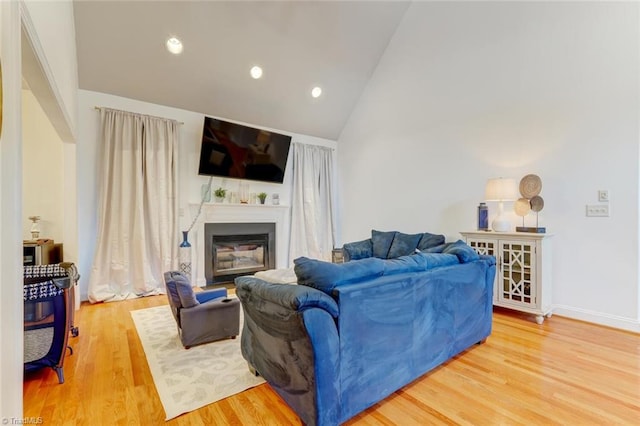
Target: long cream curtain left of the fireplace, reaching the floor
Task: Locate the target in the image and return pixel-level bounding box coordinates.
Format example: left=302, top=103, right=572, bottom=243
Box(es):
left=89, top=108, right=179, bottom=303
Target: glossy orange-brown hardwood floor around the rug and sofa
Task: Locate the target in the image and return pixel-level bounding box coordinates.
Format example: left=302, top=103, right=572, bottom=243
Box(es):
left=24, top=296, right=640, bottom=425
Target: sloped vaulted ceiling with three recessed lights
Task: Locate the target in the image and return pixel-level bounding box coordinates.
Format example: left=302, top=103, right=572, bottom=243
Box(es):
left=74, top=0, right=409, bottom=140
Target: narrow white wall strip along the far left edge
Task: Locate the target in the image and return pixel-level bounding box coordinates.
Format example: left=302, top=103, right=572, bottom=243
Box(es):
left=0, top=2, right=23, bottom=419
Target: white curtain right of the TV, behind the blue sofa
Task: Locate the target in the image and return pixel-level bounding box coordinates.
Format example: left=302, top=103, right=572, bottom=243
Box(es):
left=289, top=143, right=335, bottom=261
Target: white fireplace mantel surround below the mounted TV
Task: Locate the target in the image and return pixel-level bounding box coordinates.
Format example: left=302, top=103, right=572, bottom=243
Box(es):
left=189, top=203, right=289, bottom=287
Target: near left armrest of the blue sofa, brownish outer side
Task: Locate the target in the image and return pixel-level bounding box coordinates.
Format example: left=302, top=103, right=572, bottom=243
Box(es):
left=235, top=276, right=340, bottom=425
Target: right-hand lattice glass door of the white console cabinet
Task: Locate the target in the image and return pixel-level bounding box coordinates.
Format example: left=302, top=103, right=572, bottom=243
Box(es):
left=498, top=241, right=536, bottom=306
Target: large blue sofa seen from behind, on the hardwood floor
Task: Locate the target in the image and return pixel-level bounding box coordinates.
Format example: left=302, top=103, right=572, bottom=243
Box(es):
left=235, top=231, right=495, bottom=425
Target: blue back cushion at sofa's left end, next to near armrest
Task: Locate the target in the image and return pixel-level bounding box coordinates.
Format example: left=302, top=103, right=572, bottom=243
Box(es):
left=293, top=257, right=384, bottom=295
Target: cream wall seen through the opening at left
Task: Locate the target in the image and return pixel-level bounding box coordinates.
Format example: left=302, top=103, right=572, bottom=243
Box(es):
left=22, top=90, right=64, bottom=243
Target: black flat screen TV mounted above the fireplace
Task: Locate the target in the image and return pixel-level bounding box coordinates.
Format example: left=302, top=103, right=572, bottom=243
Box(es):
left=198, top=117, right=291, bottom=183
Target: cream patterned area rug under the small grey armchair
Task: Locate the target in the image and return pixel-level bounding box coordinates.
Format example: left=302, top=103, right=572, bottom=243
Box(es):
left=131, top=305, right=264, bottom=420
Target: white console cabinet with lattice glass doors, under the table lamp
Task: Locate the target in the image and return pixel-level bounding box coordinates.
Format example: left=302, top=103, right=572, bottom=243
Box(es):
left=461, top=231, right=552, bottom=324
